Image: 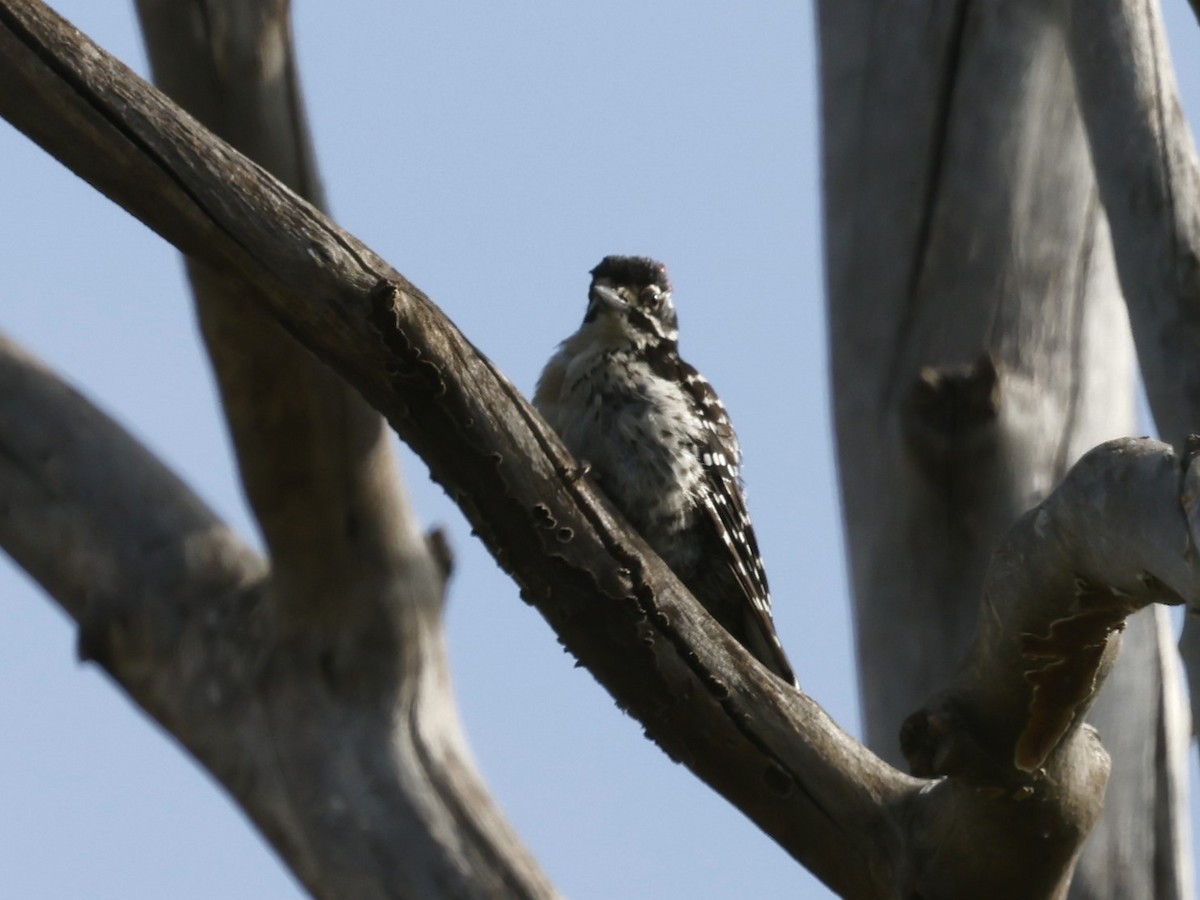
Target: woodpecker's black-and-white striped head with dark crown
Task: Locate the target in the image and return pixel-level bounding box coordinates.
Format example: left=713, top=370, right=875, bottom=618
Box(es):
left=583, top=257, right=679, bottom=349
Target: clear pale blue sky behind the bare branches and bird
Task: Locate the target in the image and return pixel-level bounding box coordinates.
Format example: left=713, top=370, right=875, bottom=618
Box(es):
left=0, top=0, right=1200, bottom=900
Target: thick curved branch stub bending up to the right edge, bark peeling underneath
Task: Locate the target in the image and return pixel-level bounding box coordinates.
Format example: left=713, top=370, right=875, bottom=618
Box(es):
left=901, top=438, right=1200, bottom=787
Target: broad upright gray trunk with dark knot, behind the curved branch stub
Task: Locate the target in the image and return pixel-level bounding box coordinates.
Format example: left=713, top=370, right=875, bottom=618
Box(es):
left=820, top=0, right=1194, bottom=896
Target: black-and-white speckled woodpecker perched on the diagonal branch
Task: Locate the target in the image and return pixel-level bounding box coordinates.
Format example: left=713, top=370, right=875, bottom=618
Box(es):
left=533, top=256, right=796, bottom=684
